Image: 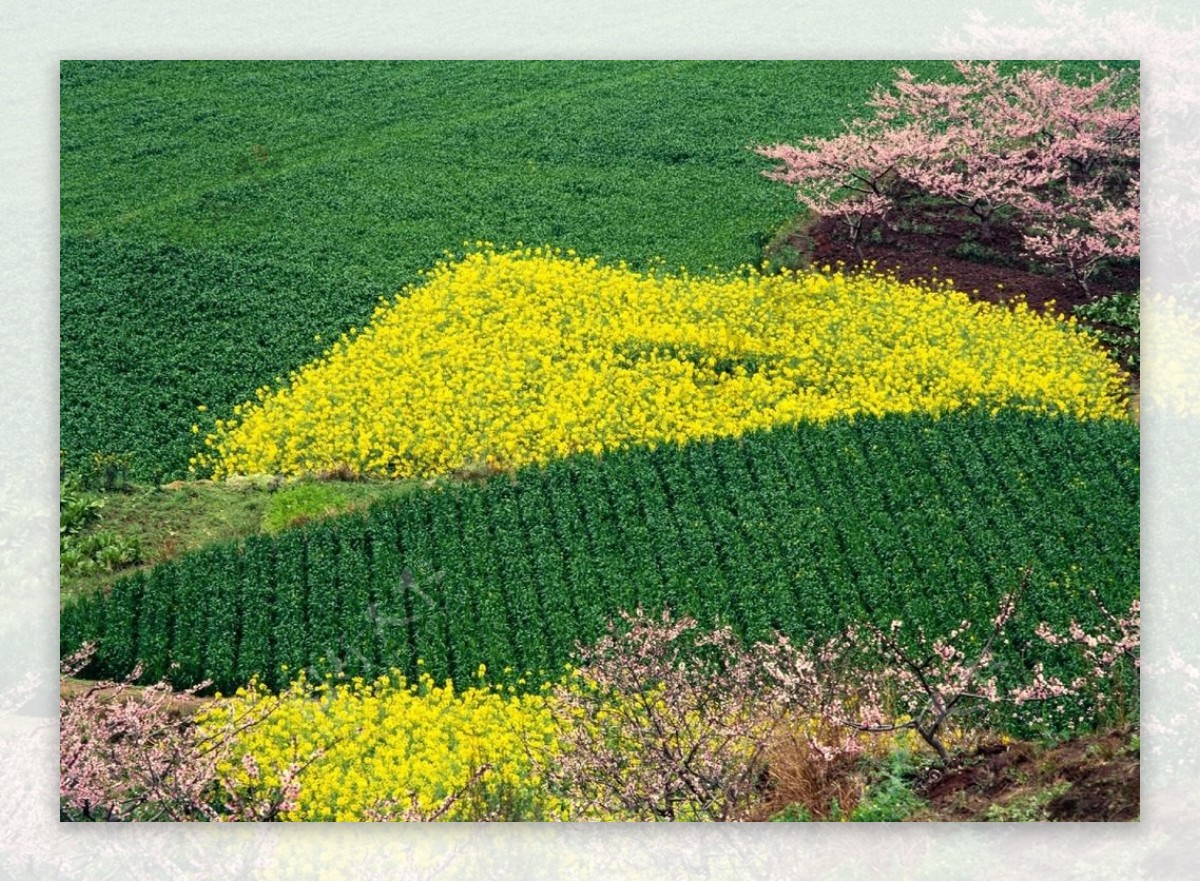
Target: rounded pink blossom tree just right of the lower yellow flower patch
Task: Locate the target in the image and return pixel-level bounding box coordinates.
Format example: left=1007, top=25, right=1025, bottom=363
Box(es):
left=545, top=608, right=781, bottom=821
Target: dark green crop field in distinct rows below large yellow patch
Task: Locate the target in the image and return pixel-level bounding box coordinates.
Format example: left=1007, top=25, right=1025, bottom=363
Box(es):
left=61, top=412, right=1139, bottom=705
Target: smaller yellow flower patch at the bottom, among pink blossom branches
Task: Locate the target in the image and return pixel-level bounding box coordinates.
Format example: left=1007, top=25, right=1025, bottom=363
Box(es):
left=198, top=670, right=566, bottom=821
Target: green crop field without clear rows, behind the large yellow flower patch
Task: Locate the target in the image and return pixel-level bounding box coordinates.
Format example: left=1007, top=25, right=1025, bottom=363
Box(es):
left=60, top=61, right=1123, bottom=479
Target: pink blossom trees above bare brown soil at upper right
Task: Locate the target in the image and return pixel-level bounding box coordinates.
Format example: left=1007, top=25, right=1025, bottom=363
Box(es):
left=756, top=61, right=1141, bottom=298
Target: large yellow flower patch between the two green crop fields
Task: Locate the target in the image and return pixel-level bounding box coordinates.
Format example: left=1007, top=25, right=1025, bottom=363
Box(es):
left=193, top=244, right=1127, bottom=478
